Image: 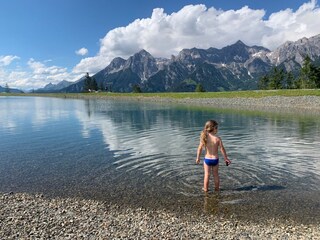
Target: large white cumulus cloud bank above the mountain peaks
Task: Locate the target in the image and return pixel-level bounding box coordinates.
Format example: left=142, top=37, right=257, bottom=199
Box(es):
left=73, top=0, right=320, bottom=73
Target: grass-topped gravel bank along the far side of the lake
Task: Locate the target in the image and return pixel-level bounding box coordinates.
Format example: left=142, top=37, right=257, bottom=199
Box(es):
left=0, top=92, right=320, bottom=115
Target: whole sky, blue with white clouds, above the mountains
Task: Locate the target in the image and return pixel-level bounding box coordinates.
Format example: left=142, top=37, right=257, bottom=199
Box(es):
left=0, top=0, right=320, bottom=90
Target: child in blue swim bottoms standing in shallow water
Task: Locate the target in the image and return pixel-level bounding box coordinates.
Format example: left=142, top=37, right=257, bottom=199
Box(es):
left=196, top=120, right=231, bottom=192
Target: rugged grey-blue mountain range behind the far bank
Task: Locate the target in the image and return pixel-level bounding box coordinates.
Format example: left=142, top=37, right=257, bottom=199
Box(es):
left=60, top=34, right=320, bottom=92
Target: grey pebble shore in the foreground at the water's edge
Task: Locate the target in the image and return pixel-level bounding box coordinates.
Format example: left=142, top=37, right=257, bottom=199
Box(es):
left=0, top=193, right=320, bottom=239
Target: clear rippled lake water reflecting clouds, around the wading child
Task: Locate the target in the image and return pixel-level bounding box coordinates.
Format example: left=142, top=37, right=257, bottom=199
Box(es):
left=0, top=97, right=320, bottom=222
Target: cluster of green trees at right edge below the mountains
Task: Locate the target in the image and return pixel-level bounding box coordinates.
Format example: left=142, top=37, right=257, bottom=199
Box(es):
left=258, top=56, right=320, bottom=90
